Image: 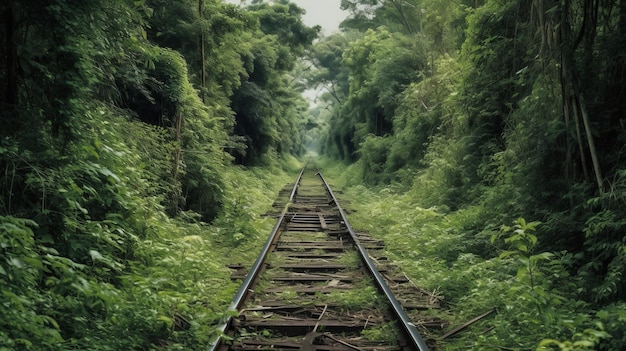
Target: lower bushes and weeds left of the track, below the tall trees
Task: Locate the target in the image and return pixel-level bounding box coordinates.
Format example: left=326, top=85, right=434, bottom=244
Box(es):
left=0, top=108, right=299, bottom=351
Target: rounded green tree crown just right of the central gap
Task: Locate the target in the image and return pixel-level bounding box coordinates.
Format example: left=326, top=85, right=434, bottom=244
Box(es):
left=314, top=27, right=426, bottom=166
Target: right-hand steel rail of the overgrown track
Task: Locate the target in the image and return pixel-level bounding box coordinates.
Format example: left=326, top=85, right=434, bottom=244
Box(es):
left=317, top=169, right=428, bottom=351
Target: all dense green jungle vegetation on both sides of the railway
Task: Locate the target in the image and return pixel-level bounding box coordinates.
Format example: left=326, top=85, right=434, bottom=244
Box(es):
left=0, top=0, right=626, bottom=350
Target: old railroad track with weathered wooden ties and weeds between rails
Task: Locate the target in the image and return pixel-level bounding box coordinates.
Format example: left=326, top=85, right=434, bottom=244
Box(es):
left=211, top=166, right=445, bottom=351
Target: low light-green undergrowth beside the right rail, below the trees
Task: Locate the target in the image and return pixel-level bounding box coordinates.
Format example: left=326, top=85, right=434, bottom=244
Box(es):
left=321, top=162, right=625, bottom=350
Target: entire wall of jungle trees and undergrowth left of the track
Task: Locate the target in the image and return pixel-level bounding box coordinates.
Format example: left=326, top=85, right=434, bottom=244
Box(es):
left=0, top=0, right=312, bottom=350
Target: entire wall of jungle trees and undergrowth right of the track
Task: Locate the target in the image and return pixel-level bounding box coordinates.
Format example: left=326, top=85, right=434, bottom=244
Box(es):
left=311, top=0, right=626, bottom=350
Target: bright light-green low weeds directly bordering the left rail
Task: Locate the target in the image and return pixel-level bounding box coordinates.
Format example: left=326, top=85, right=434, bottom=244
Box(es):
left=128, top=161, right=292, bottom=349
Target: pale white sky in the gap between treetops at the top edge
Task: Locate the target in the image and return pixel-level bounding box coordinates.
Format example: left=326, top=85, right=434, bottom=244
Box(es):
left=224, top=0, right=348, bottom=36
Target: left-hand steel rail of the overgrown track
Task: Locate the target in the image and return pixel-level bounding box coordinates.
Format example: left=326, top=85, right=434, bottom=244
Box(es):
left=209, top=164, right=307, bottom=351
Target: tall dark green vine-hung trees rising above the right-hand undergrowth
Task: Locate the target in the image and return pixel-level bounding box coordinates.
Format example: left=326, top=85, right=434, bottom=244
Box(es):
left=311, top=0, right=626, bottom=350
